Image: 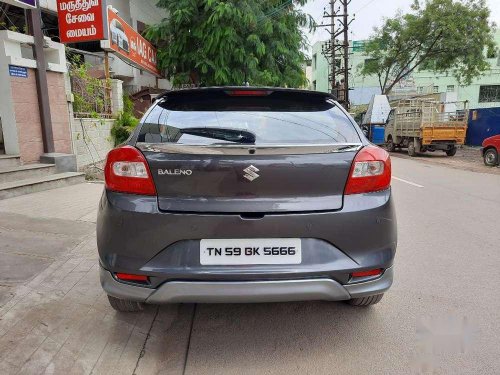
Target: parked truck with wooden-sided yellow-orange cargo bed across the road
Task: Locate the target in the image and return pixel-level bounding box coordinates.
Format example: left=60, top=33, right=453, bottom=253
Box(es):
left=385, top=97, right=469, bottom=156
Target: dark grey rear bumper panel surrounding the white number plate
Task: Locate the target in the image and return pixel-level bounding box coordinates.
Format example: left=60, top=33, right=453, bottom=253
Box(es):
left=97, top=190, right=397, bottom=283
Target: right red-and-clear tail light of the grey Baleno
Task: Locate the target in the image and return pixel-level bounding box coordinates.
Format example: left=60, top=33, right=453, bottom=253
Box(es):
left=345, top=145, right=391, bottom=195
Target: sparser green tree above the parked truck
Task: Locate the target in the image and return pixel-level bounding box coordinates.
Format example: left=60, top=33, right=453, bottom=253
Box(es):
left=361, top=0, right=495, bottom=94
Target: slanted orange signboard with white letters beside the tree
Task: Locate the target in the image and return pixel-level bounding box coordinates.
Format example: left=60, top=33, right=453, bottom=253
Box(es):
left=101, top=8, right=160, bottom=76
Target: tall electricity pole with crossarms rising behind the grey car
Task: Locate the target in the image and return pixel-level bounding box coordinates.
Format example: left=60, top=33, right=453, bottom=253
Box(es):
left=322, top=0, right=352, bottom=109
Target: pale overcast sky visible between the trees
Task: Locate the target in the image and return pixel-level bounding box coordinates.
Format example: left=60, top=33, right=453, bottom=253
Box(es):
left=304, top=0, right=500, bottom=45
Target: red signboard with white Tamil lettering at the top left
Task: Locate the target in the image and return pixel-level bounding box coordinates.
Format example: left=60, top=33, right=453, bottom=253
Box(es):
left=57, top=0, right=107, bottom=43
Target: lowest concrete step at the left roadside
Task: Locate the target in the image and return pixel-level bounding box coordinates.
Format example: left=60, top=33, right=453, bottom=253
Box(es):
left=0, top=172, right=85, bottom=199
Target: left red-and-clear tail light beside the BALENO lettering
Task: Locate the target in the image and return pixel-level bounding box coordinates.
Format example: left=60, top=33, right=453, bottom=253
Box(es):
left=104, top=146, right=156, bottom=195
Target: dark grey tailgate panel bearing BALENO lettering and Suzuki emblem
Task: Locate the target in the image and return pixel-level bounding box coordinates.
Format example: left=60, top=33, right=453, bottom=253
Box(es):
left=144, top=152, right=356, bottom=213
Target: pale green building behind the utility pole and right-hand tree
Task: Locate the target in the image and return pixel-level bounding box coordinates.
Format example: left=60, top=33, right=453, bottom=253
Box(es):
left=311, top=30, right=500, bottom=108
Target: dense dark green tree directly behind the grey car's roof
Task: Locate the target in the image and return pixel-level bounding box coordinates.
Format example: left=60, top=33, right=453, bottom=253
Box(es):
left=146, top=0, right=314, bottom=87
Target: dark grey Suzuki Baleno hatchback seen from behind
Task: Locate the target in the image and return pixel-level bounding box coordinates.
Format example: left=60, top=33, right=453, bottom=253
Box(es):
left=97, top=87, right=397, bottom=311
